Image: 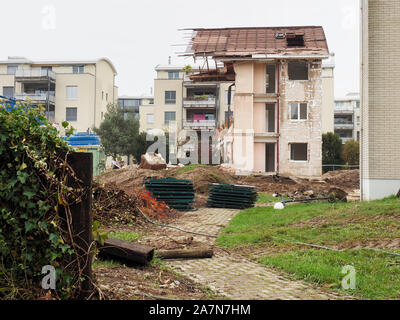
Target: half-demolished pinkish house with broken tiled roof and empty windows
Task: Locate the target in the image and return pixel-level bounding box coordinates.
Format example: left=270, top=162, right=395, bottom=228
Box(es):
left=186, top=26, right=333, bottom=178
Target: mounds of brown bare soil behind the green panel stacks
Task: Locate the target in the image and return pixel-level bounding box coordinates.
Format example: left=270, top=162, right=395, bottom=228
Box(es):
left=97, top=166, right=359, bottom=202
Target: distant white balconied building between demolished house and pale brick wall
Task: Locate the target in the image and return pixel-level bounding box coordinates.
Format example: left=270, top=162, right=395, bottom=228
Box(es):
left=335, top=93, right=361, bottom=143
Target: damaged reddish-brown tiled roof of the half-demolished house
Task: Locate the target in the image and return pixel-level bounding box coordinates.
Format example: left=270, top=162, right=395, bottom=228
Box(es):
left=187, top=26, right=329, bottom=58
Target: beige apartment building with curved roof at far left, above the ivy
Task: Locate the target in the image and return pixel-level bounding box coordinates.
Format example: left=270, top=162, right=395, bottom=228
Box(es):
left=0, top=57, right=118, bottom=132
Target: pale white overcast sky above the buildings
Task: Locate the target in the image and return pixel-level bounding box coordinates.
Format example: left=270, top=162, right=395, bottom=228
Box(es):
left=0, top=0, right=360, bottom=97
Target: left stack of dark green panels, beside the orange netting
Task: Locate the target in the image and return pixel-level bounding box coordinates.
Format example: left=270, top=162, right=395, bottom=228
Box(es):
left=144, top=178, right=194, bottom=211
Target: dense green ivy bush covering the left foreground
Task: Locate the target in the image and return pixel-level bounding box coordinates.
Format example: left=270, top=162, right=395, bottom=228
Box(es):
left=0, top=103, right=83, bottom=299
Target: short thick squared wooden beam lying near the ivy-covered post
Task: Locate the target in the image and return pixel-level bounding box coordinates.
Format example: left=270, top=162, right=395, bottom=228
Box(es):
left=99, top=238, right=154, bottom=264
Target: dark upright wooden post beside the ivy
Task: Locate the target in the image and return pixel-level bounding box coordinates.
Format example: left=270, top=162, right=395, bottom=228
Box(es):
left=60, top=152, right=93, bottom=299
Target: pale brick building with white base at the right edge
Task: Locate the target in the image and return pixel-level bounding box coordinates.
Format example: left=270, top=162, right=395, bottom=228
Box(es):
left=361, top=0, right=400, bottom=200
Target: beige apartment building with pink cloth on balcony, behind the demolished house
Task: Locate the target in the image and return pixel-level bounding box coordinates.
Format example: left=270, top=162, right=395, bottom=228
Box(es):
left=139, top=64, right=234, bottom=131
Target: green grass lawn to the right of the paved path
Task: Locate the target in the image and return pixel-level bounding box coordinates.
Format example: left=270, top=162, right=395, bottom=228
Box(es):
left=217, top=197, right=400, bottom=299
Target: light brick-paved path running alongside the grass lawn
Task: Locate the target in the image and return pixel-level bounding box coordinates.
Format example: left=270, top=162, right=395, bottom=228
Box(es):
left=155, top=208, right=340, bottom=300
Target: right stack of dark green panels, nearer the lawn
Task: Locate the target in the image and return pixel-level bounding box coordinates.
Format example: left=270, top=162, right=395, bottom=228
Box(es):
left=207, top=183, right=258, bottom=209
